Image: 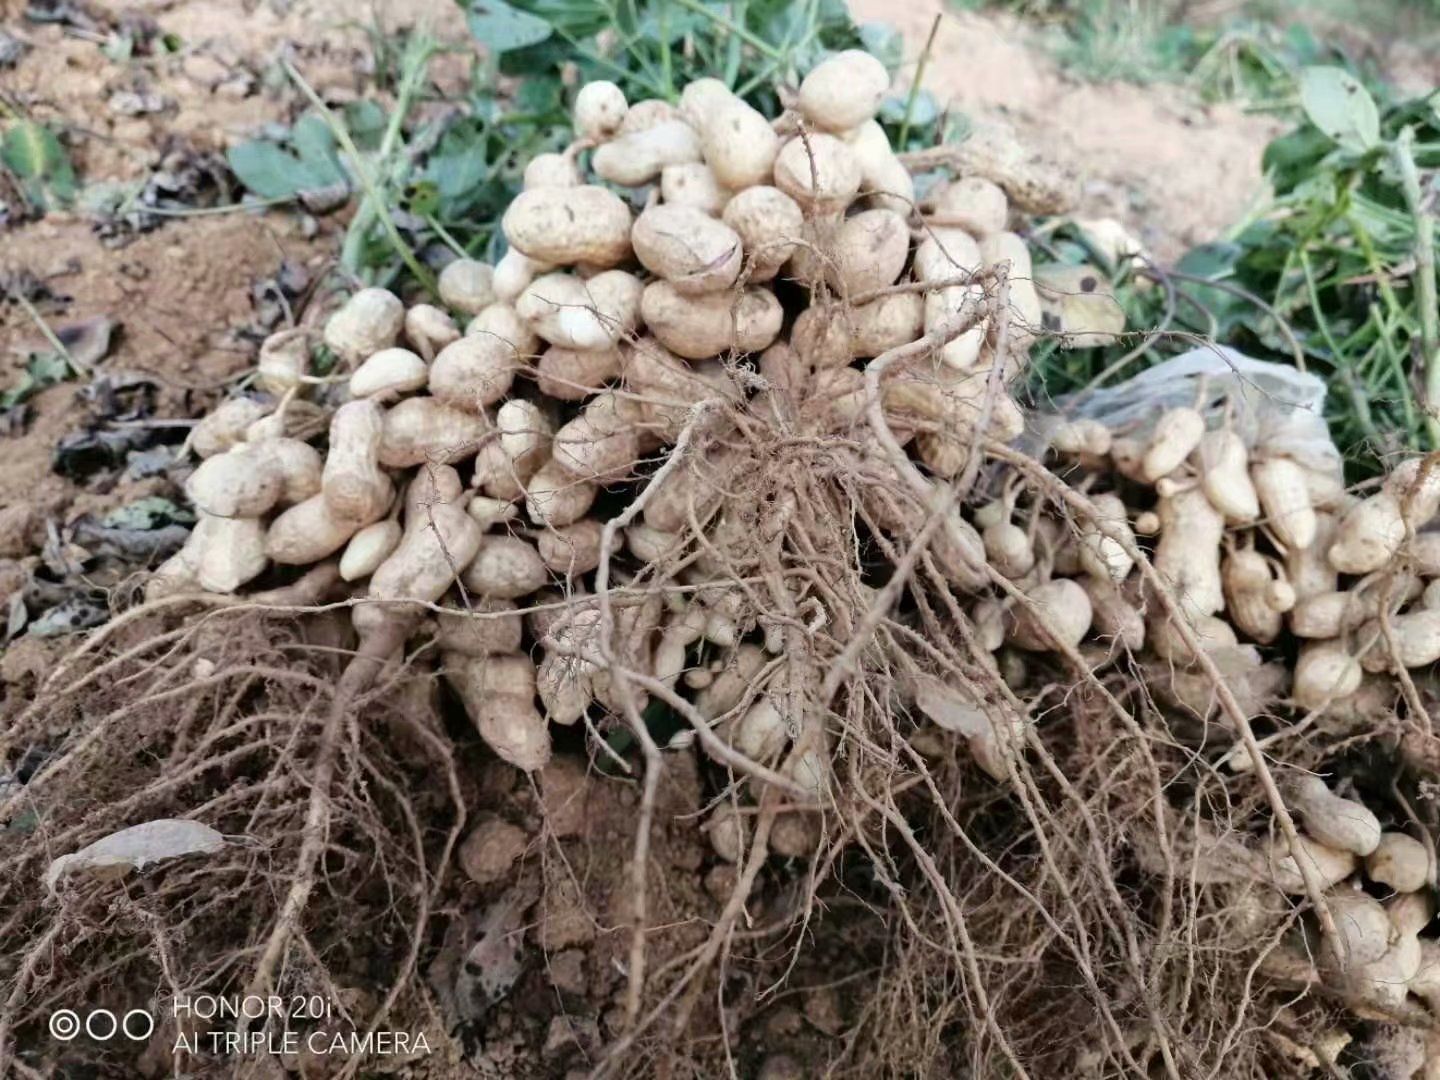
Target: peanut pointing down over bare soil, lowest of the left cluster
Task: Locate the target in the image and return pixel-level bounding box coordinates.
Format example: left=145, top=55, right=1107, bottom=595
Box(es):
left=442, top=654, right=550, bottom=772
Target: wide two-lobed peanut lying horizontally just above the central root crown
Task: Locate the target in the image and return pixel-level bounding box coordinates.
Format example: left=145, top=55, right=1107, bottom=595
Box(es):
left=641, top=281, right=785, bottom=360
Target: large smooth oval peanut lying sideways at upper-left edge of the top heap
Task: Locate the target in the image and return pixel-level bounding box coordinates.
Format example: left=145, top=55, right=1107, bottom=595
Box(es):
left=501, top=184, right=631, bottom=268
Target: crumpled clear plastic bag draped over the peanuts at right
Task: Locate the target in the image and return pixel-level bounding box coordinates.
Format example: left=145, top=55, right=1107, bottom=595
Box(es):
left=1032, top=346, right=1341, bottom=472
